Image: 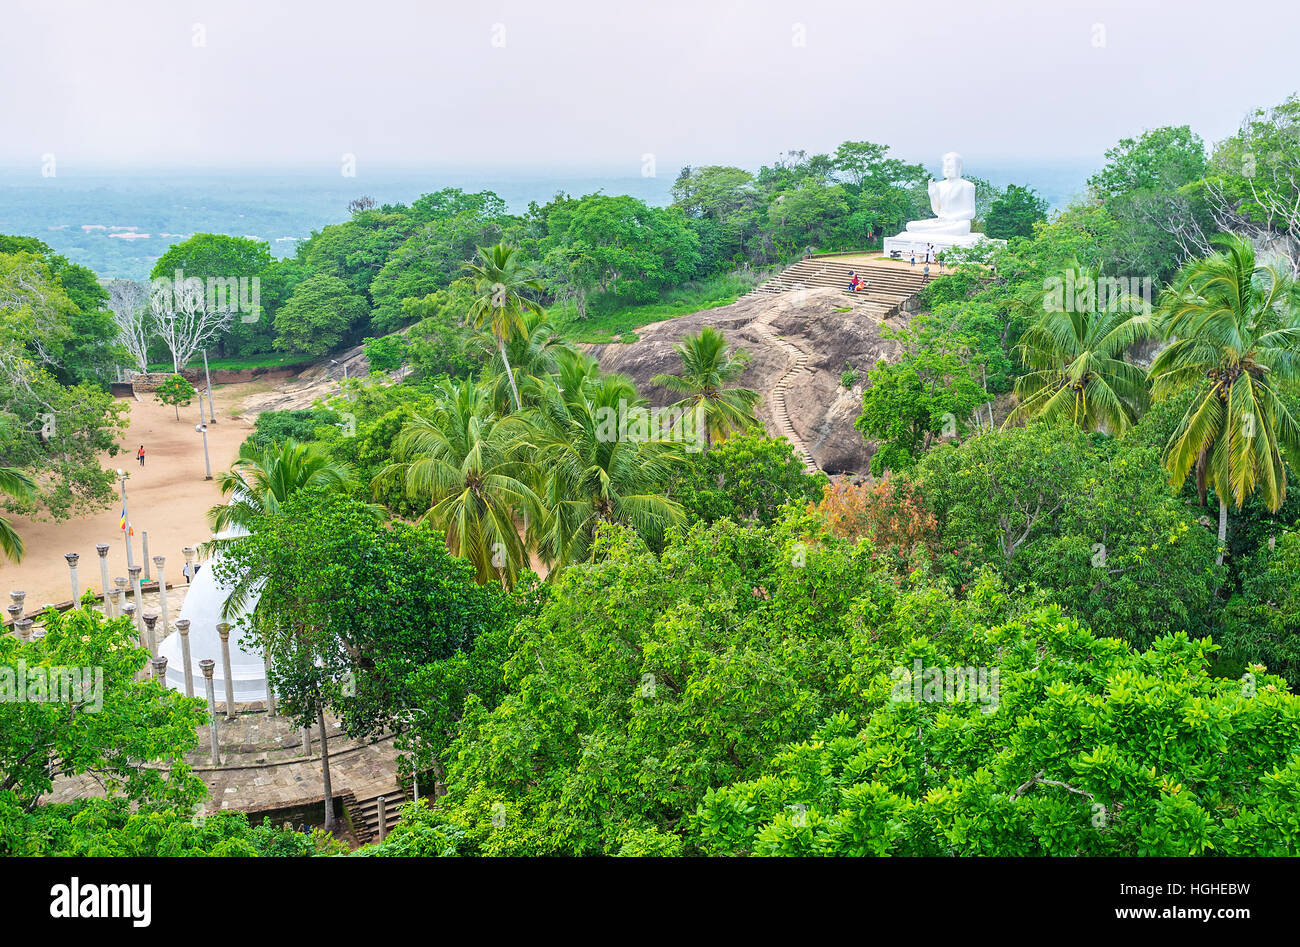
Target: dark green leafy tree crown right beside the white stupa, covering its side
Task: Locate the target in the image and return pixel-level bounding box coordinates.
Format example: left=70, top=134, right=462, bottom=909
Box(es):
left=217, top=488, right=516, bottom=766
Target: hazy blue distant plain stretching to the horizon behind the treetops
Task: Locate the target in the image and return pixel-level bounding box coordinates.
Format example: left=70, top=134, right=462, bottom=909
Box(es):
left=0, top=161, right=1091, bottom=280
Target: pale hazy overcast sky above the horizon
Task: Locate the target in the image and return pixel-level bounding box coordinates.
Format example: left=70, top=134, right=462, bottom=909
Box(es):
left=0, top=0, right=1300, bottom=177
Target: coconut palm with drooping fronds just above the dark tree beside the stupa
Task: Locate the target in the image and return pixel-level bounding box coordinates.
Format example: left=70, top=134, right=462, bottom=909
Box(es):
left=376, top=380, right=540, bottom=585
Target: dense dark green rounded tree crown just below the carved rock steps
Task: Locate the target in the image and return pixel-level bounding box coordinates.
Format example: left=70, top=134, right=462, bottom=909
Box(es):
left=671, top=431, right=827, bottom=526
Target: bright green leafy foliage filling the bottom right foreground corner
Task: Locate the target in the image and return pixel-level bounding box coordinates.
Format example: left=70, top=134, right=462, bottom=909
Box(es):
left=699, top=610, right=1300, bottom=856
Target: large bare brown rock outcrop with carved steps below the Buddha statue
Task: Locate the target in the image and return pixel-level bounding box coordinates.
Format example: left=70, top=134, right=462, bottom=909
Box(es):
left=582, top=287, right=902, bottom=474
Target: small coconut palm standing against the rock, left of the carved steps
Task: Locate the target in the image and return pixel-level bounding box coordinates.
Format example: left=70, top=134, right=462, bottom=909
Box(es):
left=650, top=325, right=762, bottom=446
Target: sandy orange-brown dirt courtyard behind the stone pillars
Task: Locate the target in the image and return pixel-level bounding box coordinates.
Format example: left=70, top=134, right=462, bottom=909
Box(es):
left=0, top=381, right=263, bottom=613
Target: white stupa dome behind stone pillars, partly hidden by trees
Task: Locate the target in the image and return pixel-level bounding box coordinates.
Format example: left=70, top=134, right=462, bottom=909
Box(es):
left=159, top=529, right=267, bottom=704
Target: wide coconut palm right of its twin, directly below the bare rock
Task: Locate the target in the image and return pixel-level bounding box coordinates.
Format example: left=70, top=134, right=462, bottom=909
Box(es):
left=533, top=366, right=685, bottom=567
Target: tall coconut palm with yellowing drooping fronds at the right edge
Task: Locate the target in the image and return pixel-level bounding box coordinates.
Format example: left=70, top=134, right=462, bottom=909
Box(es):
left=1151, top=235, right=1300, bottom=563
